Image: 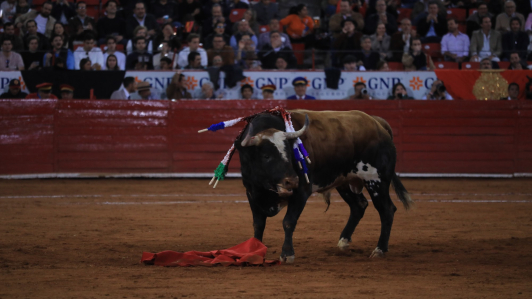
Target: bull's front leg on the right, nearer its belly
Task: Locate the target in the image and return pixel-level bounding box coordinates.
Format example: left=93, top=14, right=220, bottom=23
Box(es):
left=280, top=198, right=306, bottom=263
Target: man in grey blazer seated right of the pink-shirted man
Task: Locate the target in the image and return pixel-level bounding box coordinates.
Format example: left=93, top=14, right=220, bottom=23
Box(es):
left=469, top=16, right=502, bottom=61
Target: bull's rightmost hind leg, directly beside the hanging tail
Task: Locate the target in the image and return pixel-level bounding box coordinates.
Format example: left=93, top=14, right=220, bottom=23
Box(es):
left=366, top=180, right=397, bottom=258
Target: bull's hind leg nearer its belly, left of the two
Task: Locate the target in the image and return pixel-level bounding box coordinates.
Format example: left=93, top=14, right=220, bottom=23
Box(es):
left=336, top=185, right=368, bottom=250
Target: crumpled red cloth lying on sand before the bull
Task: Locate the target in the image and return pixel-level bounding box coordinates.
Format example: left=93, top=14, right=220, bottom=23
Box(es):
left=140, top=238, right=280, bottom=267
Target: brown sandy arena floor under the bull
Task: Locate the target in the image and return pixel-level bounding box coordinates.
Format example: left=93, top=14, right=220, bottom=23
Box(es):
left=0, top=179, right=532, bottom=298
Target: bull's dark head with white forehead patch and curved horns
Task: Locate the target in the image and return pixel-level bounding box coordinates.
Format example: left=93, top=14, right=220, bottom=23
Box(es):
left=237, top=116, right=309, bottom=197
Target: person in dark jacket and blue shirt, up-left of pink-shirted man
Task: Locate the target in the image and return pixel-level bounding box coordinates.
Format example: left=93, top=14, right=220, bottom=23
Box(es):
left=415, top=0, right=447, bottom=43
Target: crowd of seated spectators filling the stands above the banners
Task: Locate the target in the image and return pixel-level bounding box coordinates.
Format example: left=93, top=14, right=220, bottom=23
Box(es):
left=0, top=0, right=532, bottom=101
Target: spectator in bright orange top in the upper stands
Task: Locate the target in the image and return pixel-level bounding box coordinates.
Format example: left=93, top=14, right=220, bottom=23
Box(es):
left=279, top=4, right=314, bottom=42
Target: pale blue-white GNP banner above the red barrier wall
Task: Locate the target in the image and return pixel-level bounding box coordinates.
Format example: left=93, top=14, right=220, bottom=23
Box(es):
left=125, top=71, right=436, bottom=100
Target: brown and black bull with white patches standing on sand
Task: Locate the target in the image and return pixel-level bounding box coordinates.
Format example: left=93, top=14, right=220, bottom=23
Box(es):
left=234, top=110, right=413, bottom=263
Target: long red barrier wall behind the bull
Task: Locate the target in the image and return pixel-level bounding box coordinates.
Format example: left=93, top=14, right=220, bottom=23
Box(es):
left=0, top=100, right=532, bottom=175
